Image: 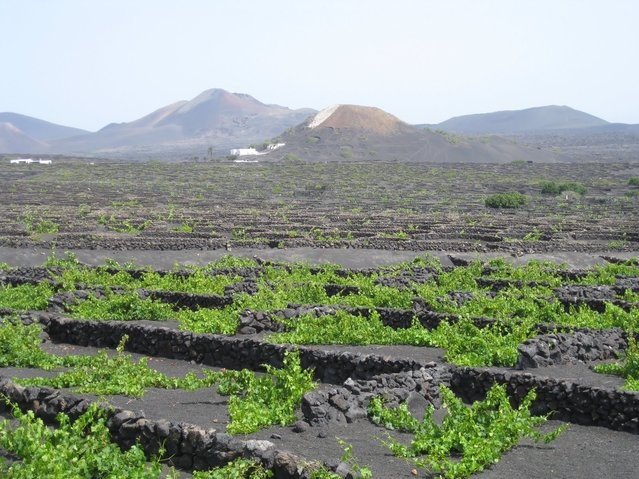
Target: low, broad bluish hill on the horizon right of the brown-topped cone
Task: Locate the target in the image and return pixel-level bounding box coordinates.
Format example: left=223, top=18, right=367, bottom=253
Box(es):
left=432, top=105, right=608, bottom=134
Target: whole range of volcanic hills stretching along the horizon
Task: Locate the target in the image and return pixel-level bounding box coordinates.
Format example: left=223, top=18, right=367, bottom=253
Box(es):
left=0, top=95, right=639, bottom=162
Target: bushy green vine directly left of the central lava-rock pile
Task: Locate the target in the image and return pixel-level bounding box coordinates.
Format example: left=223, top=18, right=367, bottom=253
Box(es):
left=219, top=351, right=315, bottom=434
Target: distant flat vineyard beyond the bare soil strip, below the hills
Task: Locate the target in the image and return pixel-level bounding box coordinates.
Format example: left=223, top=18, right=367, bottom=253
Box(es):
left=0, top=158, right=639, bottom=254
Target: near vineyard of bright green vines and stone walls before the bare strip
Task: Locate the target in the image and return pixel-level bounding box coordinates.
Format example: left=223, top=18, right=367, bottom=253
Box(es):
left=0, top=253, right=639, bottom=477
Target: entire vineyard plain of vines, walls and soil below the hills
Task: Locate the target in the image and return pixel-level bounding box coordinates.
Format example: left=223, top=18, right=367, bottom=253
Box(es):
left=0, top=158, right=639, bottom=479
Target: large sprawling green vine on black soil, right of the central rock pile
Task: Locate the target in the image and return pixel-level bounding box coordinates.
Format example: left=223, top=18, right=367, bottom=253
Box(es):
left=368, top=384, right=563, bottom=479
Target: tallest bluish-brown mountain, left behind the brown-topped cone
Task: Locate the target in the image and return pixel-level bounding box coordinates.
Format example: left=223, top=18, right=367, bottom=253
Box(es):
left=54, top=89, right=315, bottom=154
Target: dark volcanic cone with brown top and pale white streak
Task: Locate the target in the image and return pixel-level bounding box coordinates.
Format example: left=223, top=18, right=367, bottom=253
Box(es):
left=268, top=105, right=560, bottom=163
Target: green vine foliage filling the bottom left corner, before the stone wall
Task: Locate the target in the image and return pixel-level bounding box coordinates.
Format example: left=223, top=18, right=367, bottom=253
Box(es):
left=0, top=404, right=177, bottom=479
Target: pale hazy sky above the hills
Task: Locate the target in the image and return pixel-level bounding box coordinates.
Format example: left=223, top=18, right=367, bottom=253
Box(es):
left=0, top=0, right=639, bottom=130
